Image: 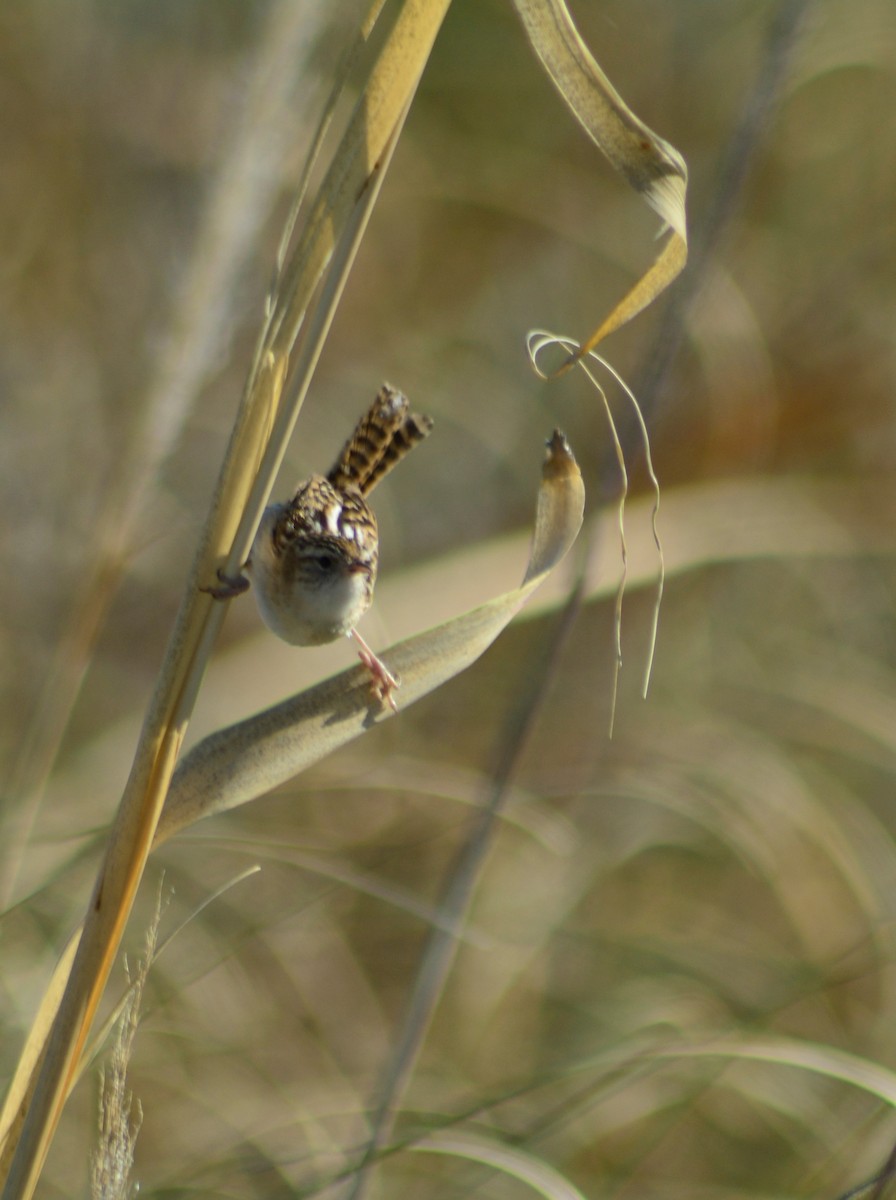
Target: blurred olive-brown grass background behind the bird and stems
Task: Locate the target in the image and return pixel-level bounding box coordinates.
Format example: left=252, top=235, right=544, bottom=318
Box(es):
left=0, top=0, right=896, bottom=1198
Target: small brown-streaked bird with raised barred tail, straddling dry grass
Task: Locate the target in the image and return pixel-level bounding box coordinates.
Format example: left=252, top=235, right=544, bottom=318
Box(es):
left=205, top=384, right=433, bottom=710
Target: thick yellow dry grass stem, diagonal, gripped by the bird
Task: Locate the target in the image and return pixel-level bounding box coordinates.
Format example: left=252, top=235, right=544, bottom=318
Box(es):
left=2, top=7, right=446, bottom=1200
